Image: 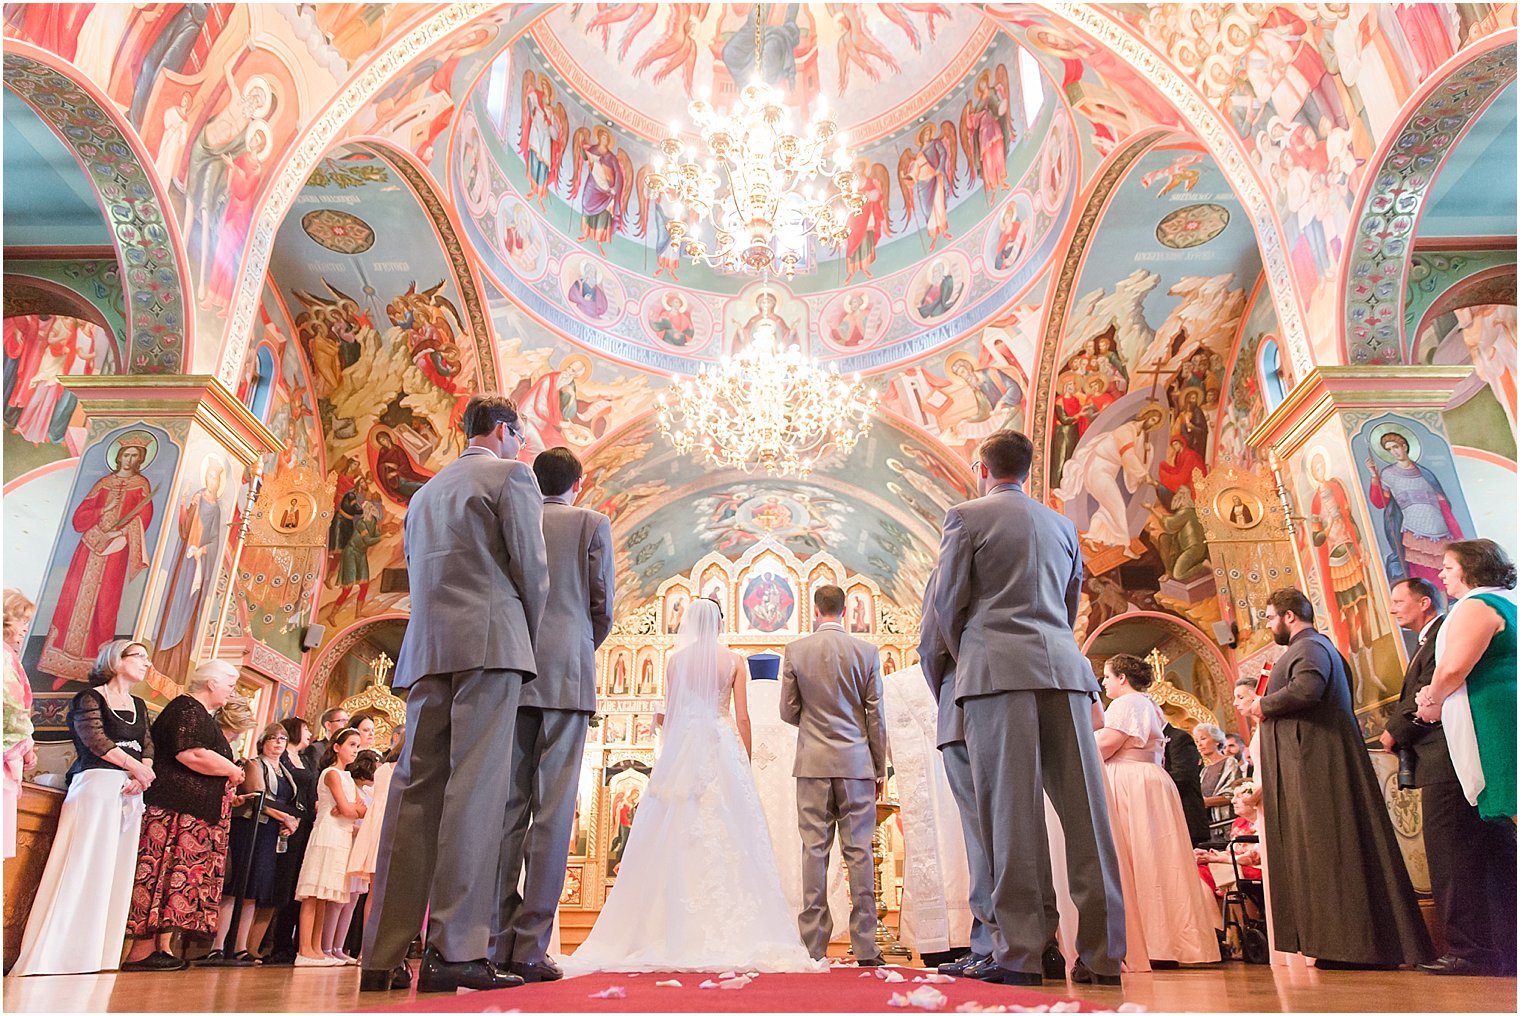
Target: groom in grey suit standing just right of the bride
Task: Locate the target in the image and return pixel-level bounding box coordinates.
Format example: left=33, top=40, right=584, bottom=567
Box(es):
left=781, top=586, right=886, bottom=966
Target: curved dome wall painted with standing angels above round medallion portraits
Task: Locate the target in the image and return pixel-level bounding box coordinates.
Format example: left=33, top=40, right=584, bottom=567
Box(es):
left=451, top=22, right=1078, bottom=373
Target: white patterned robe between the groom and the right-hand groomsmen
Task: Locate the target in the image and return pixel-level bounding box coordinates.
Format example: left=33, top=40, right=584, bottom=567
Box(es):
left=882, top=663, right=971, bottom=954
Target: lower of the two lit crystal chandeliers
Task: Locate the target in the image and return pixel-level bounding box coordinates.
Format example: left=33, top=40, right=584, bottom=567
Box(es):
left=657, top=317, right=877, bottom=478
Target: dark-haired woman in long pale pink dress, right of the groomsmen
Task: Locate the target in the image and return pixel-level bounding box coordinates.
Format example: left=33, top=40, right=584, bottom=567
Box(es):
left=1096, top=652, right=1219, bottom=972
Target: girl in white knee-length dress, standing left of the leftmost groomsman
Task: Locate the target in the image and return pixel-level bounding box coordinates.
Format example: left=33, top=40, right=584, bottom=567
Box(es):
left=295, top=727, right=365, bottom=967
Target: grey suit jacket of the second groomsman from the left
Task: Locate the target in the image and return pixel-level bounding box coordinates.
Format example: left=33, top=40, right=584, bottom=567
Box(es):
left=518, top=497, right=614, bottom=713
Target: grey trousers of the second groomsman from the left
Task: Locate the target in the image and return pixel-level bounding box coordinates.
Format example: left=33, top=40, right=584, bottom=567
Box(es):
left=491, top=706, right=591, bottom=964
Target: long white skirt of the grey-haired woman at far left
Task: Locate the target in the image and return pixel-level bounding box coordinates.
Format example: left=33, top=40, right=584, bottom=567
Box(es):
left=11, top=768, right=143, bottom=975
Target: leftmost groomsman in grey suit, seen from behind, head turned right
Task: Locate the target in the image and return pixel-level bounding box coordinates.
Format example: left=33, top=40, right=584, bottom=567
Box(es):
left=359, top=395, right=549, bottom=992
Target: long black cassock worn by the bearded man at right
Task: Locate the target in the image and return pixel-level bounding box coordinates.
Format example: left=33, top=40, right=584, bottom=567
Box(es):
left=1262, top=630, right=1432, bottom=964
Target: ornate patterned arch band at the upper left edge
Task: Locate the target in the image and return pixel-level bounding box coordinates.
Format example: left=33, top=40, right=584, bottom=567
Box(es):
left=5, top=40, right=193, bottom=374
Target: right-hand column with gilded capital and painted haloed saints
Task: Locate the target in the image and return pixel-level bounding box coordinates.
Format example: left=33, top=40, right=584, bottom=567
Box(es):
left=1251, top=367, right=1477, bottom=738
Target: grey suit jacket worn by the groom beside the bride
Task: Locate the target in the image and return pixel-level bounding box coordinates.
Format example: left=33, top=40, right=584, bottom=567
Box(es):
left=781, top=624, right=886, bottom=780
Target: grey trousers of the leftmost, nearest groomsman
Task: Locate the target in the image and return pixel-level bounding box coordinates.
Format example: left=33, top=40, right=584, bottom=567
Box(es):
left=363, top=669, right=523, bottom=970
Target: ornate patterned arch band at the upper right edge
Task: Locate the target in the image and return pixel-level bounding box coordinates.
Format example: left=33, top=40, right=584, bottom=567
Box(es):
left=1339, top=29, right=1515, bottom=365
